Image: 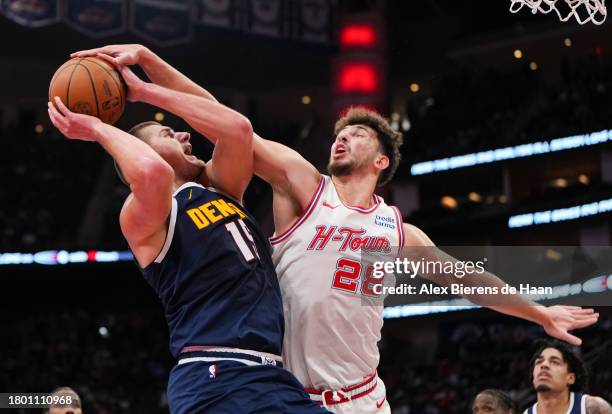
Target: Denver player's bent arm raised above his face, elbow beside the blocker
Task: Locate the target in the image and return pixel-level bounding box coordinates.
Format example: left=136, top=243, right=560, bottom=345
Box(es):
left=112, top=62, right=253, bottom=200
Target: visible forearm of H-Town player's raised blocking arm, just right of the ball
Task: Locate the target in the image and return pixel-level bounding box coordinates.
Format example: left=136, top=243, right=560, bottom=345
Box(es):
left=139, top=49, right=217, bottom=102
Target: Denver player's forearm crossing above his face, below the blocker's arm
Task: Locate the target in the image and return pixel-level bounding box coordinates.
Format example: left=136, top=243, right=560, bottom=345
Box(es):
left=139, top=83, right=253, bottom=144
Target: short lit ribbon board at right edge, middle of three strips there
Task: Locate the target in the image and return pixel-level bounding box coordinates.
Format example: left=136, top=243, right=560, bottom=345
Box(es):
left=508, top=198, right=612, bottom=229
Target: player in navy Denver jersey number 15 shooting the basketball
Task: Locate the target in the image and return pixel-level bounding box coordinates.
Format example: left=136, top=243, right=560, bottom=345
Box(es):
left=48, top=68, right=327, bottom=414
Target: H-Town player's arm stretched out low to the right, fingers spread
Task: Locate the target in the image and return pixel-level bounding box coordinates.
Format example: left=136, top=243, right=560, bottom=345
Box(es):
left=404, top=223, right=599, bottom=345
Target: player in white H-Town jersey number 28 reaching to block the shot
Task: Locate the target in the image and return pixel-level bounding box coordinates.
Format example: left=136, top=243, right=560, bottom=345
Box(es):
left=72, top=45, right=597, bottom=414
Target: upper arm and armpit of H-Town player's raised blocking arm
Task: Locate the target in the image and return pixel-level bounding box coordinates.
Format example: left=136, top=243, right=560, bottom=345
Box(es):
left=253, top=134, right=321, bottom=209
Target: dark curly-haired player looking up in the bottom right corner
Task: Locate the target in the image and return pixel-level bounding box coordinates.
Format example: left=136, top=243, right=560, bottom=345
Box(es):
left=524, top=341, right=612, bottom=414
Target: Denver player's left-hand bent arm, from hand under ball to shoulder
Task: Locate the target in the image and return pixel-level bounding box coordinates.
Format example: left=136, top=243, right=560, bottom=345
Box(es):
left=48, top=98, right=174, bottom=267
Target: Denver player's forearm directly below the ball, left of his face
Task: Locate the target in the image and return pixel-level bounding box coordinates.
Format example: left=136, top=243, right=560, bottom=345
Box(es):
left=95, top=123, right=174, bottom=187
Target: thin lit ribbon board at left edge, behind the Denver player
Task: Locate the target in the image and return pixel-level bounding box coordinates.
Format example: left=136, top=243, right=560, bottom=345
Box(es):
left=0, top=250, right=134, bottom=265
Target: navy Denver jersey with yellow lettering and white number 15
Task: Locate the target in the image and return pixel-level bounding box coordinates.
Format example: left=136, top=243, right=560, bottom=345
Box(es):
left=142, top=183, right=284, bottom=357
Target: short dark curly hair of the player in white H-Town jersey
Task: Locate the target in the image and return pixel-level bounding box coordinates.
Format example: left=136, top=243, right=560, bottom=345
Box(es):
left=334, top=106, right=403, bottom=186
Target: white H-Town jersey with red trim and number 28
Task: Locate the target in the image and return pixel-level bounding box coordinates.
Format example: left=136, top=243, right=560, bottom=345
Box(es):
left=270, top=176, right=404, bottom=389
